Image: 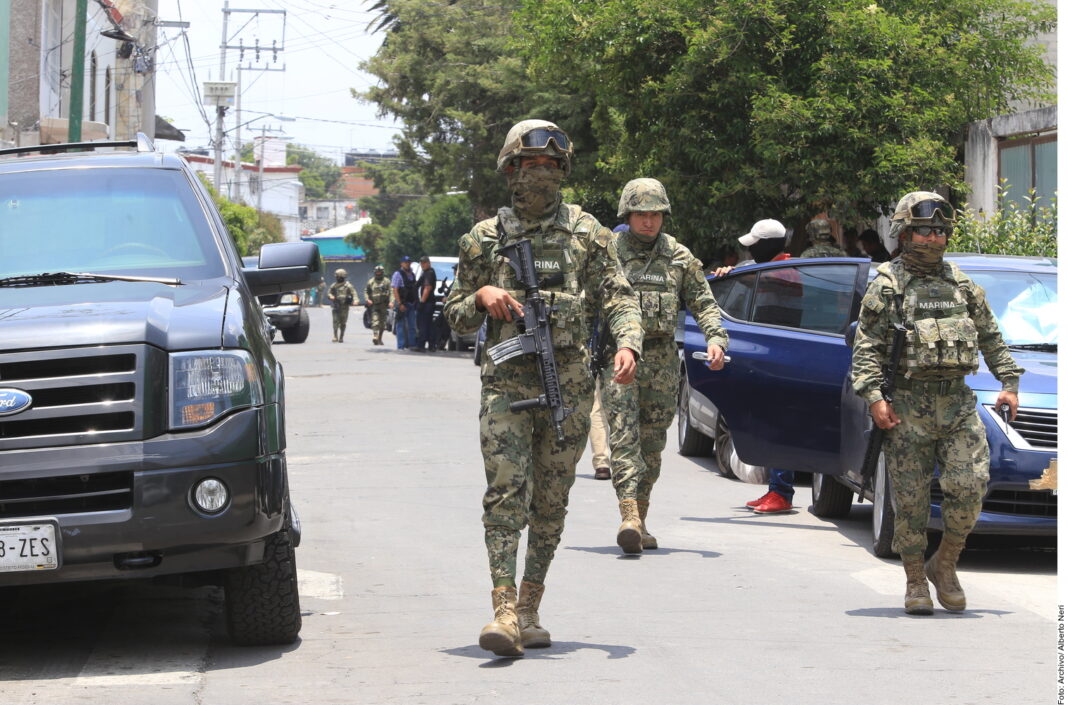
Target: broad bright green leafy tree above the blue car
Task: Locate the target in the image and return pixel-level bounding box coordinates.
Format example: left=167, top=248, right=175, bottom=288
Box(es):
left=514, top=0, right=1055, bottom=256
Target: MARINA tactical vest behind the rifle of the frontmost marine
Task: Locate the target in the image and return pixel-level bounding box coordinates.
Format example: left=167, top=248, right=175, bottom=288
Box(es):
left=483, top=205, right=592, bottom=347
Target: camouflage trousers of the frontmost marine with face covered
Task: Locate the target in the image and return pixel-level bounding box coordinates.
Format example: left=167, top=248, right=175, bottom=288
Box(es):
left=478, top=348, right=593, bottom=586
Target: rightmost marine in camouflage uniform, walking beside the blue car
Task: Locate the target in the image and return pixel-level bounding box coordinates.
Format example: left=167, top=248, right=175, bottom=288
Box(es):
left=853, top=191, right=1024, bottom=614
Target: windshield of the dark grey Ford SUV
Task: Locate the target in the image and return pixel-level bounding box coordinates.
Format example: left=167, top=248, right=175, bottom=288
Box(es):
left=0, top=169, right=225, bottom=280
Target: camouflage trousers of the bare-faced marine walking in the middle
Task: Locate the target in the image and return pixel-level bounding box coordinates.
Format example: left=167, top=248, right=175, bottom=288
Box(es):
left=601, top=338, right=679, bottom=502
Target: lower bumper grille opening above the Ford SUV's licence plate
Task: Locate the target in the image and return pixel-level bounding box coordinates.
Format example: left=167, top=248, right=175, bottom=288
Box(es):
left=0, top=472, right=134, bottom=518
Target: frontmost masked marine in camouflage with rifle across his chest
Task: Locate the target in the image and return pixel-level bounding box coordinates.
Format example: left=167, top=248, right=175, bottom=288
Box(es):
left=444, top=121, right=642, bottom=656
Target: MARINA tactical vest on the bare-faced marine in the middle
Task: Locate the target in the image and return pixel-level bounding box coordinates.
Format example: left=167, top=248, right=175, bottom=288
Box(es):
left=616, top=231, right=684, bottom=339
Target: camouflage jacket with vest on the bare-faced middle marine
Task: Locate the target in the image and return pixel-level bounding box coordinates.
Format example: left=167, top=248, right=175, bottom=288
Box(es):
left=616, top=230, right=727, bottom=350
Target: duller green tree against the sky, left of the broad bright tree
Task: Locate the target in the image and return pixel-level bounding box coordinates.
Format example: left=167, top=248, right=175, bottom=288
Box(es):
left=354, top=0, right=541, bottom=217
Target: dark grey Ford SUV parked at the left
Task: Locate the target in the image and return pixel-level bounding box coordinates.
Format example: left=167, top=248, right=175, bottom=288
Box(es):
left=0, top=136, right=320, bottom=644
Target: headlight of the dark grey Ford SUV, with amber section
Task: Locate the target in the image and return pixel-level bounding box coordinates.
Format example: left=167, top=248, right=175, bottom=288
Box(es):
left=170, top=350, right=264, bottom=430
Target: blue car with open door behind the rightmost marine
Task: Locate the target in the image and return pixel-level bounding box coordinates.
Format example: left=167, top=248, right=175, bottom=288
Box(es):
left=678, top=255, right=1059, bottom=555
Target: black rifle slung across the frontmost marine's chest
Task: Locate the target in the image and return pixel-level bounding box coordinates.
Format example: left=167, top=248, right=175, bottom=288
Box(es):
left=486, top=238, right=575, bottom=441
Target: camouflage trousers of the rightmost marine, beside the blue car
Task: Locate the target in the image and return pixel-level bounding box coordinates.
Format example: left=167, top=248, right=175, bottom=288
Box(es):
left=883, top=387, right=990, bottom=554
